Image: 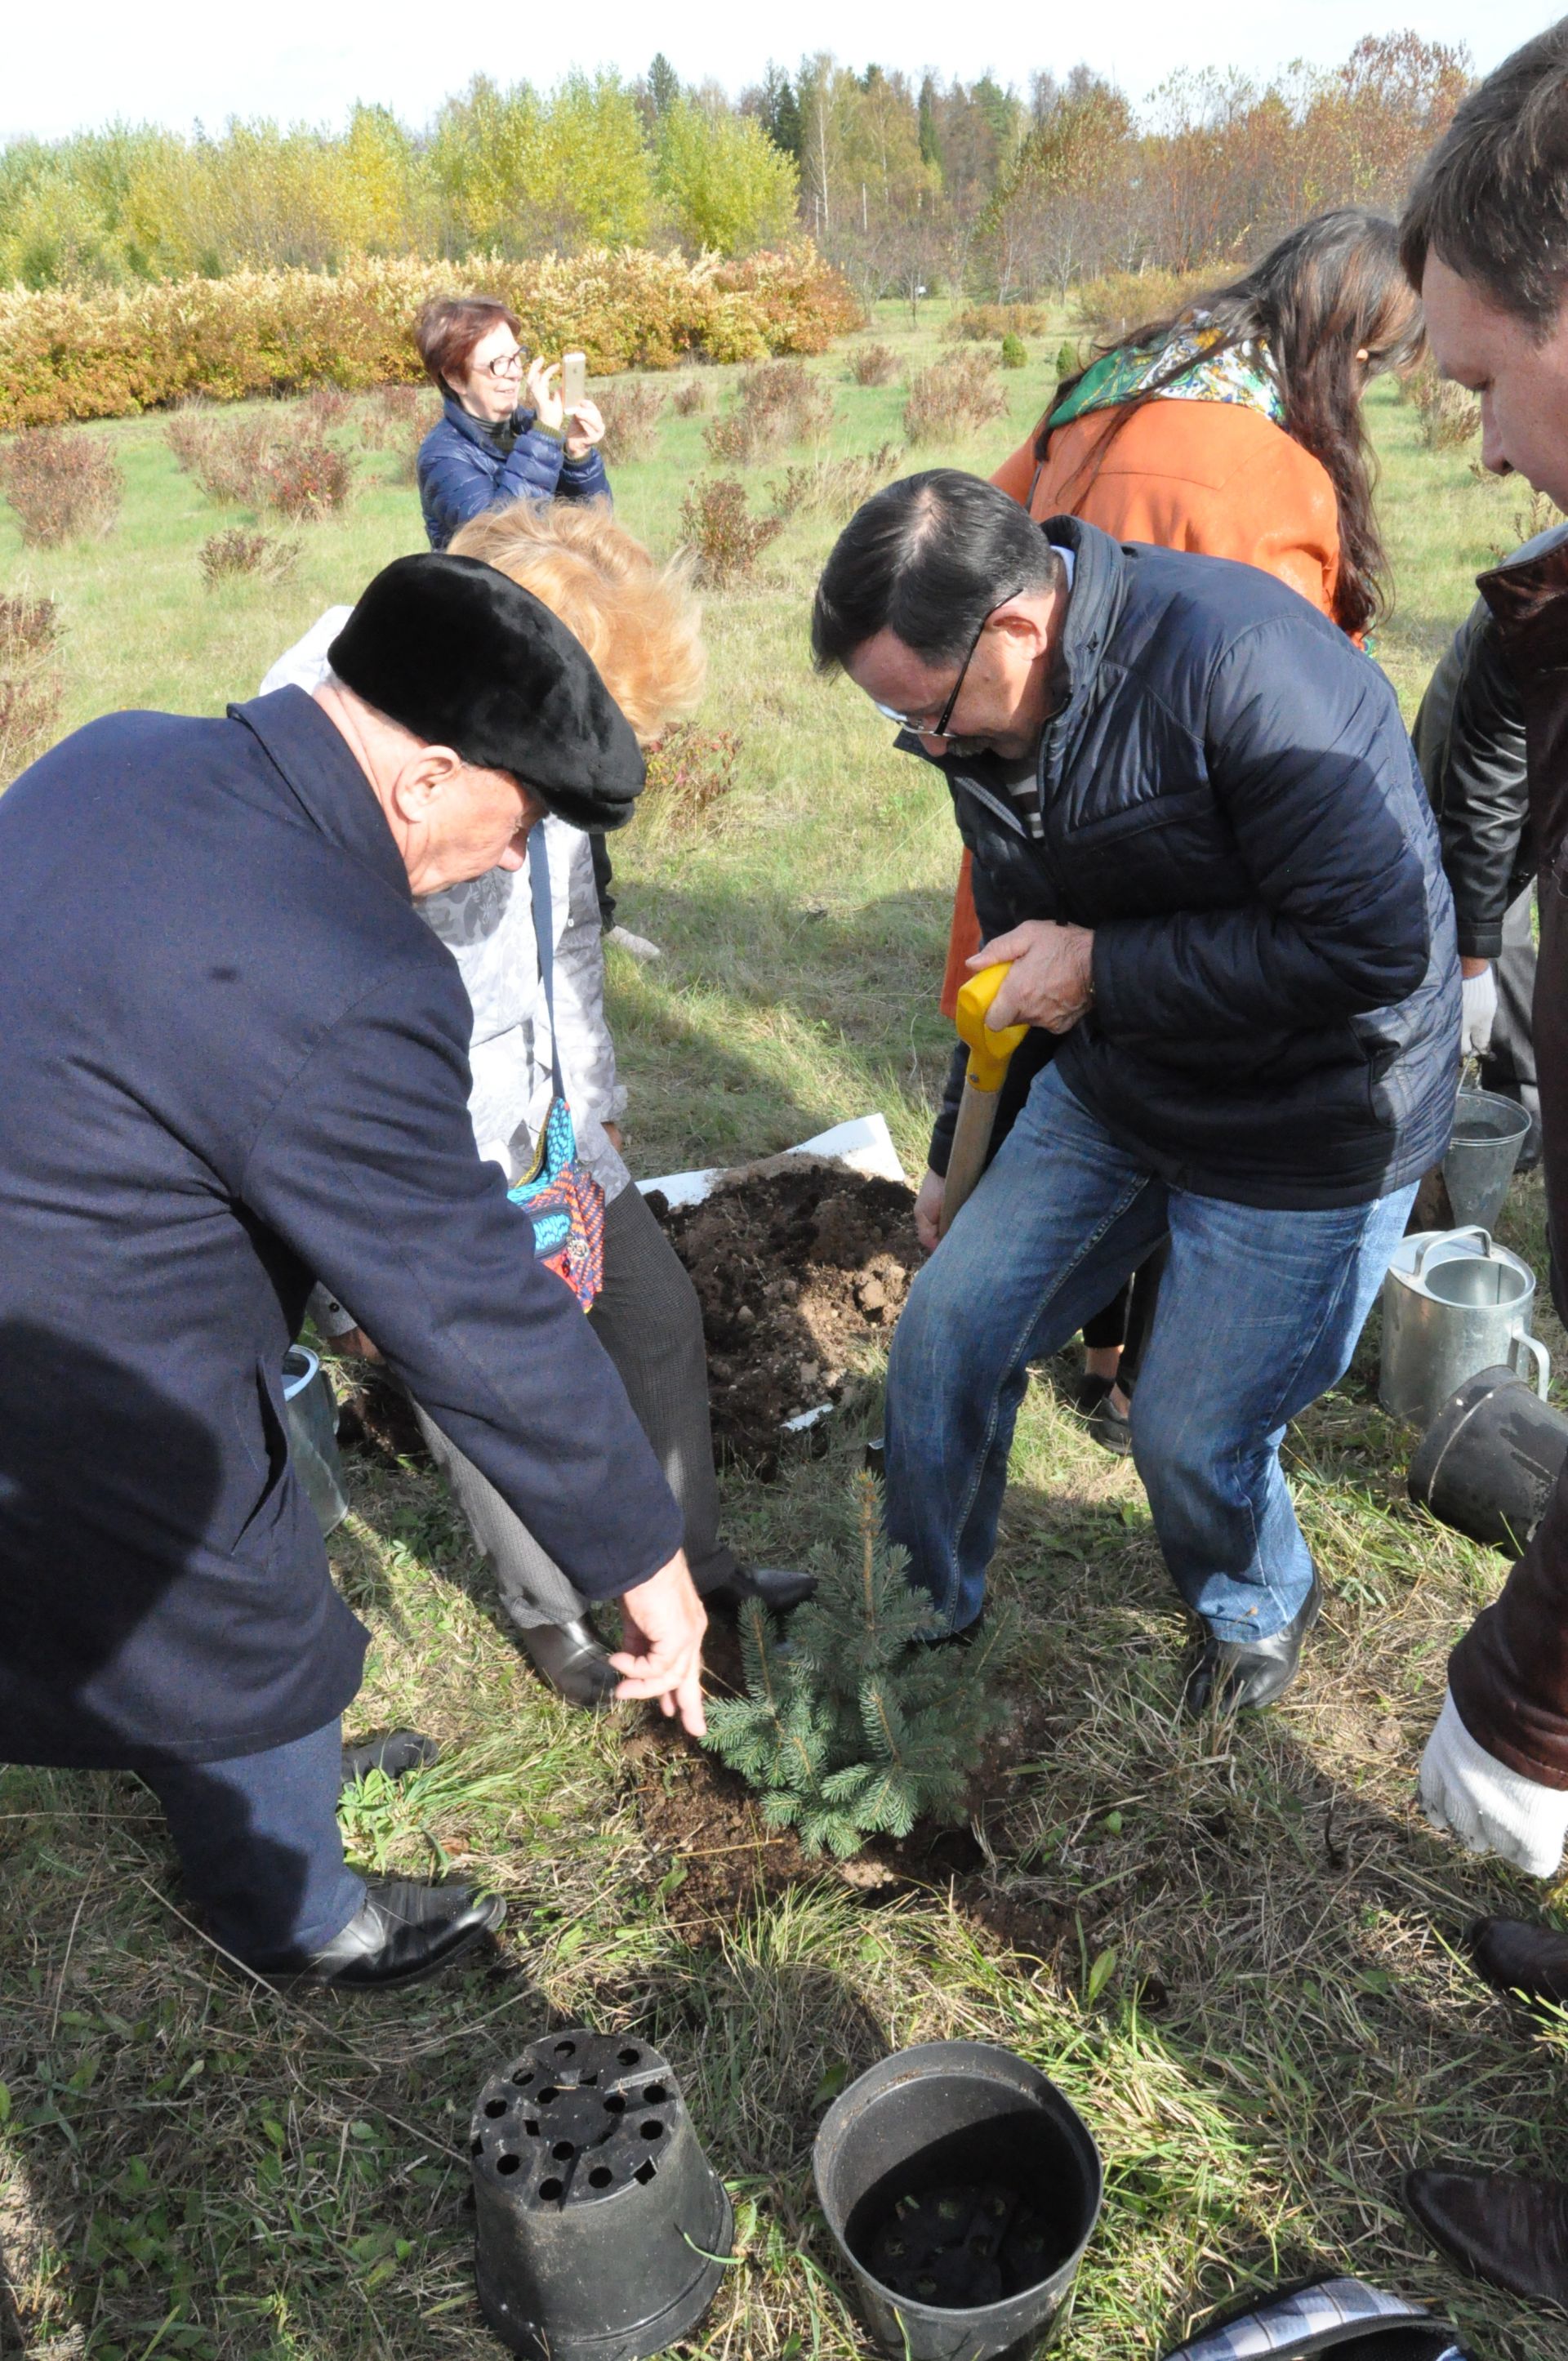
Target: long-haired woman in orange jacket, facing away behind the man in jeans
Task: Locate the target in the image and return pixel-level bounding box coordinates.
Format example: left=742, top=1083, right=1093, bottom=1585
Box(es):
left=942, top=206, right=1422, bottom=1452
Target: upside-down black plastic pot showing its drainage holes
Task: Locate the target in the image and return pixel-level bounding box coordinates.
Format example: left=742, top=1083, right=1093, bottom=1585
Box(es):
left=470, top=2025, right=734, bottom=2361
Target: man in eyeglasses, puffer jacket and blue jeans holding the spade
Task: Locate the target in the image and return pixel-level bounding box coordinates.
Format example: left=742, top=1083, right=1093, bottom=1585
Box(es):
left=813, top=470, right=1459, bottom=1709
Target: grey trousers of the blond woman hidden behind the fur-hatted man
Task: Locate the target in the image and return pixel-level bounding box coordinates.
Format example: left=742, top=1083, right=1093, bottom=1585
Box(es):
left=416, top=1187, right=734, bottom=1629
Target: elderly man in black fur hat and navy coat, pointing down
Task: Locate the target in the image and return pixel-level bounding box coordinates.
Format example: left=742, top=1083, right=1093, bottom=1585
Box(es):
left=0, top=555, right=704, bottom=1988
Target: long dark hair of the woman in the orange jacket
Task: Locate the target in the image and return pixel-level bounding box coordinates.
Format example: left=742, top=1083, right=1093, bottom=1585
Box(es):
left=1035, top=206, right=1424, bottom=630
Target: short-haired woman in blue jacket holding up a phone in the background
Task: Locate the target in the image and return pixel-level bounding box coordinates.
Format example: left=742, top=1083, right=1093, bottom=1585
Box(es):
left=413, top=295, right=609, bottom=550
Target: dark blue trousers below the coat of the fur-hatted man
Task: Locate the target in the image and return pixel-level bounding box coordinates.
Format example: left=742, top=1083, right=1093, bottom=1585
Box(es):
left=141, top=1722, right=363, bottom=1969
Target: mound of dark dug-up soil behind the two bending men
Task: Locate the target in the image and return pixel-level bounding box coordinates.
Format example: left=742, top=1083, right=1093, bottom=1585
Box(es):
left=649, top=1157, right=924, bottom=1473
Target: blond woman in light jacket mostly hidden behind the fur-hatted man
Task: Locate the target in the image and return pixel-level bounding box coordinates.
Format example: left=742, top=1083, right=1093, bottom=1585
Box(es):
left=262, top=501, right=813, bottom=1704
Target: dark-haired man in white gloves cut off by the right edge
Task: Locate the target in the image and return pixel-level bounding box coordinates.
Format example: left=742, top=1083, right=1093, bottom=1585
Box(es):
left=1401, top=19, right=1568, bottom=2307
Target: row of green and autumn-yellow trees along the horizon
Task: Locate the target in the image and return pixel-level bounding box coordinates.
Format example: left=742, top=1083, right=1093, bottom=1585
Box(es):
left=0, top=33, right=1469, bottom=302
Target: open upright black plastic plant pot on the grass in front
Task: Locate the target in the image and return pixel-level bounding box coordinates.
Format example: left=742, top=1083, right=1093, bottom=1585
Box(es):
left=813, top=2042, right=1100, bottom=2361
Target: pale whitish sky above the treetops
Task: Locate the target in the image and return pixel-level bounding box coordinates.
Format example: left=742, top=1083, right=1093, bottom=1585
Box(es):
left=0, top=0, right=1552, bottom=140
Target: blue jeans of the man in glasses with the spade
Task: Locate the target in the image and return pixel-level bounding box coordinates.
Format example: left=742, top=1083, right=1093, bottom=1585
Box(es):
left=885, top=1067, right=1414, bottom=1641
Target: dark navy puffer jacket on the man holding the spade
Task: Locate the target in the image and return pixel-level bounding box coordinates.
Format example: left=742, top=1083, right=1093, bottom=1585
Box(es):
left=930, top=517, right=1459, bottom=1206
